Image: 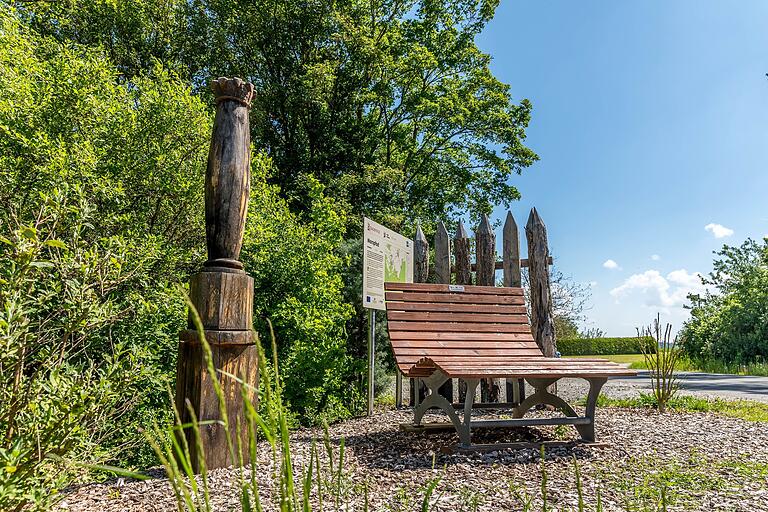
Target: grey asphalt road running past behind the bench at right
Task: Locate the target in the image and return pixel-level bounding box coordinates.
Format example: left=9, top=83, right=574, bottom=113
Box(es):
left=609, top=371, right=768, bottom=402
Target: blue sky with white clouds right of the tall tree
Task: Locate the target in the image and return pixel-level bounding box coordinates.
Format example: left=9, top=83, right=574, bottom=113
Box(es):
left=478, top=0, right=768, bottom=336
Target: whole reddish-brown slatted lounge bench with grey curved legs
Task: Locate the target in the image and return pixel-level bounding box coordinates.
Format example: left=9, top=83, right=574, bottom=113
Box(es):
left=385, top=283, right=637, bottom=447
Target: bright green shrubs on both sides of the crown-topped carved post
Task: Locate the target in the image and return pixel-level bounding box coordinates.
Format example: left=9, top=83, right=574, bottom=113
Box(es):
left=0, top=10, right=359, bottom=510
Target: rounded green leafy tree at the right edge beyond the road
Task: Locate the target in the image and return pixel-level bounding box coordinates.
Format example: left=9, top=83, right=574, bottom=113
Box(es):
left=680, top=239, right=768, bottom=364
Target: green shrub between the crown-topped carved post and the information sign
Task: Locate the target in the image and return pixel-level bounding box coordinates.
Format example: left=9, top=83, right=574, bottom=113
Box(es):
left=242, top=160, right=365, bottom=424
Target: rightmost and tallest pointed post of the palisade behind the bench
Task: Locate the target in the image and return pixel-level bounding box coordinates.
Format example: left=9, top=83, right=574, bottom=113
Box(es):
left=525, top=208, right=557, bottom=357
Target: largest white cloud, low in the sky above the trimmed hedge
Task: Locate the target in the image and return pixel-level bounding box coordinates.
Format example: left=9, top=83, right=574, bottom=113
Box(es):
left=610, top=269, right=705, bottom=308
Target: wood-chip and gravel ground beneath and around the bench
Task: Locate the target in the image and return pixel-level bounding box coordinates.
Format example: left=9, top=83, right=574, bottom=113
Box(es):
left=60, top=381, right=768, bottom=512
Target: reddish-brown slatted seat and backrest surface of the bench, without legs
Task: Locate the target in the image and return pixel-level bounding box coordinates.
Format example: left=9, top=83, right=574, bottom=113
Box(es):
left=385, top=283, right=636, bottom=379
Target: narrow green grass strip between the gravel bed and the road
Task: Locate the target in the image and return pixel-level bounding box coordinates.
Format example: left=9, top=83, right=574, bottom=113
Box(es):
left=597, top=393, right=768, bottom=422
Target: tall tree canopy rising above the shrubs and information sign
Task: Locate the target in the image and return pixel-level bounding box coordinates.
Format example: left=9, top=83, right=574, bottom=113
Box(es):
left=20, top=0, right=537, bottom=226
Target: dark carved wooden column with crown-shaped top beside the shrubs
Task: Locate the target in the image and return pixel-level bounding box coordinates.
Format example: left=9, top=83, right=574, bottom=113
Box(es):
left=176, top=78, right=259, bottom=471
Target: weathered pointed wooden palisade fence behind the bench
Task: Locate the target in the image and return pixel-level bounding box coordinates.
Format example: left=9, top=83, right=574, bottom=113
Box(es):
left=396, top=208, right=555, bottom=406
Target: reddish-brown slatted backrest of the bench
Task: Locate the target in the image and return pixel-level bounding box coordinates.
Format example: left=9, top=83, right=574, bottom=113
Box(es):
left=384, top=283, right=544, bottom=373
